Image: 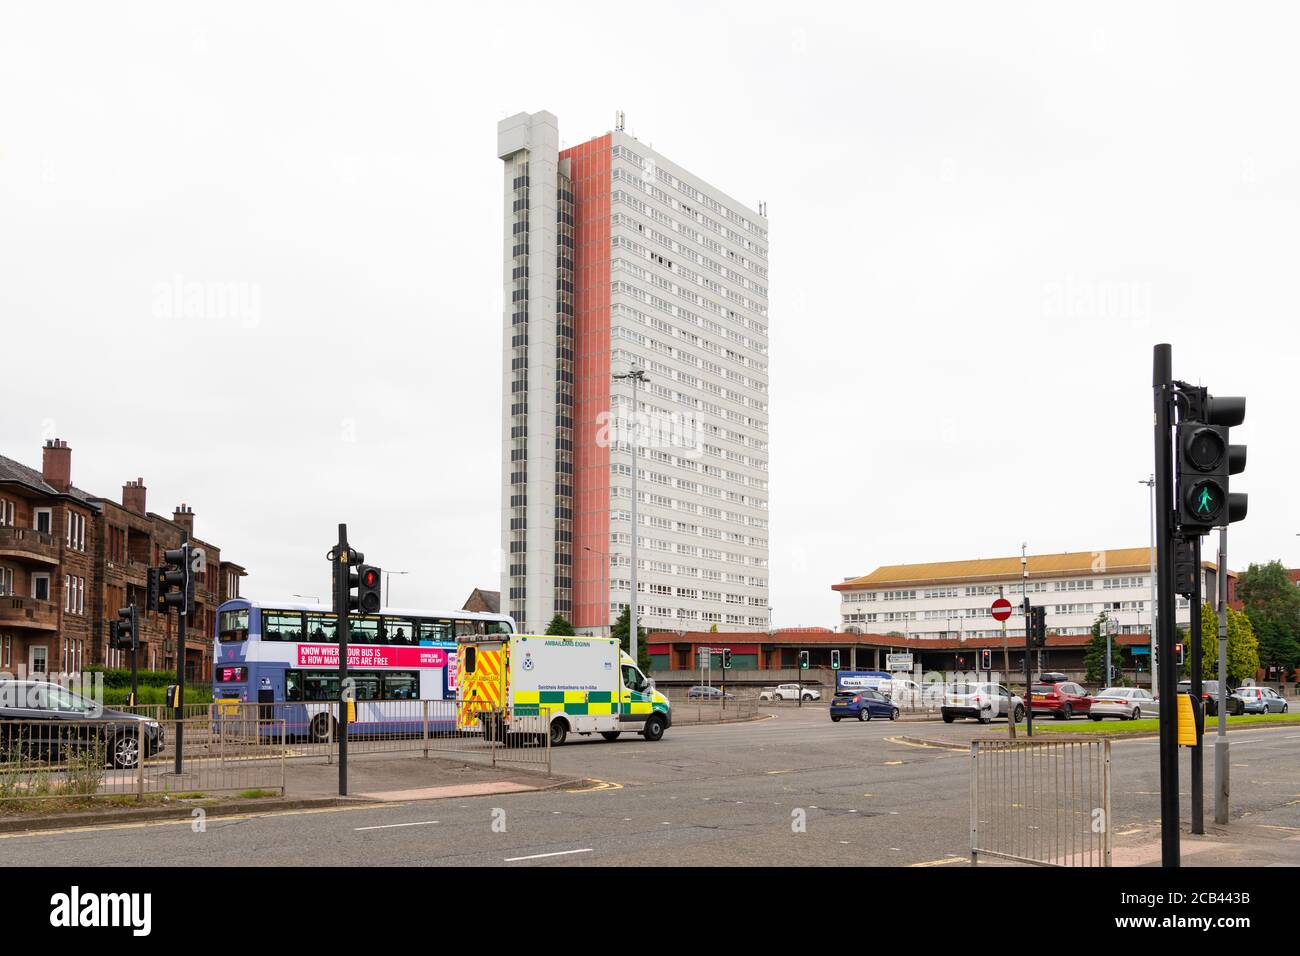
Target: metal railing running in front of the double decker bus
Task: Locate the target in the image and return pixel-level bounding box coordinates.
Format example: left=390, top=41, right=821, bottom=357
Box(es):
left=205, top=698, right=553, bottom=775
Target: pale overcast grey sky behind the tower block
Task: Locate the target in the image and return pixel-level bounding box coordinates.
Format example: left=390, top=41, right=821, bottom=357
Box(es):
left=0, top=3, right=1300, bottom=626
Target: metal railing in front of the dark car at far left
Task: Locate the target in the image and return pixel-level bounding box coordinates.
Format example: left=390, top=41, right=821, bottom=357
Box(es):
left=0, top=717, right=287, bottom=803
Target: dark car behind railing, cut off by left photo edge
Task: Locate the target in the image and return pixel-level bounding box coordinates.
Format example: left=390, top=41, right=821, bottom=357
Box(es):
left=0, top=680, right=164, bottom=769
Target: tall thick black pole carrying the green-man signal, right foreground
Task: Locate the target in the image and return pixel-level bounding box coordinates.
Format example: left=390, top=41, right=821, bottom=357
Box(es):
left=1152, top=342, right=1180, bottom=868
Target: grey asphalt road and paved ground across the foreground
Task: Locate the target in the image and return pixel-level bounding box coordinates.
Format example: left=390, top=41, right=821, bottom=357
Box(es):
left=0, top=708, right=1300, bottom=866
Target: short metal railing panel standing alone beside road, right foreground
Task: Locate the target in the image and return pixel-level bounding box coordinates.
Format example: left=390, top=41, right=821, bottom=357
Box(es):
left=970, top=739, right=1112, bottom=866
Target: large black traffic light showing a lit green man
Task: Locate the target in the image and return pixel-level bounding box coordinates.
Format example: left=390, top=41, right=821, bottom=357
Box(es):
left=1175, top=389, right=1247, bottom=537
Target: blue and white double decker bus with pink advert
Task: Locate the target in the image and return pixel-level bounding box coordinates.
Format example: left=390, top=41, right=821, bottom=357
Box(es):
left=212, top=598, right=515, bottom=740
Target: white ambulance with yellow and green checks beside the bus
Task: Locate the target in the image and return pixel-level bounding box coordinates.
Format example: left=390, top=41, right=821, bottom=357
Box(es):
left=456, top=633, right=672, bottom=747
